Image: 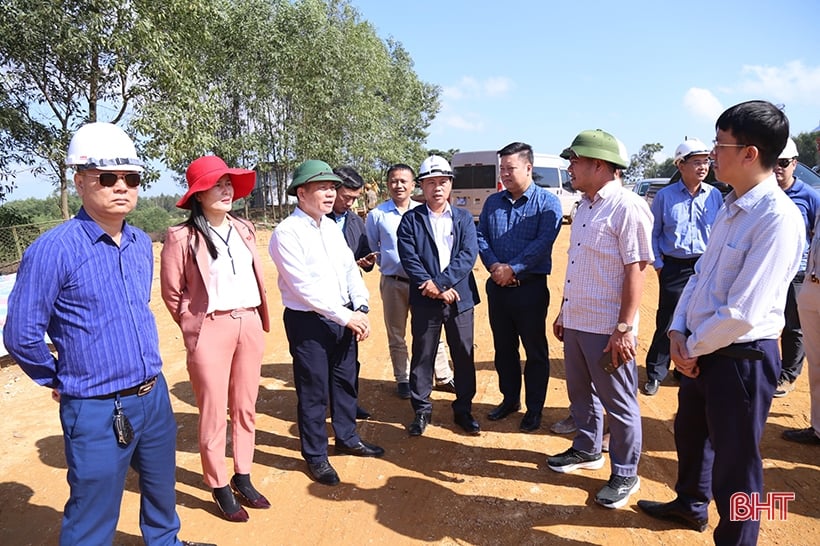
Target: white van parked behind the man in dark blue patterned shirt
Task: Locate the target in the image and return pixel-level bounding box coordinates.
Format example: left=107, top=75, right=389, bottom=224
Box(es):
left=450, top=150, right=581, bottom=222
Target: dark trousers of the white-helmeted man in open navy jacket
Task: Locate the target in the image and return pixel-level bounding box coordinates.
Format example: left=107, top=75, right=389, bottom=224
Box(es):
left=410, top=303, right=475, bottom=414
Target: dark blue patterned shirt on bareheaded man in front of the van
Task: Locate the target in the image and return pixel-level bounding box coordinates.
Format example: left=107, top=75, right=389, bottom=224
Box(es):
left=477, top=182, right=563, bottom=278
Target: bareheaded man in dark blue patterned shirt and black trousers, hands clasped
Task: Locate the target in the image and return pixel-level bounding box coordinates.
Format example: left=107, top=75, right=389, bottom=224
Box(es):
left=478, top=142, right=562, bottom=432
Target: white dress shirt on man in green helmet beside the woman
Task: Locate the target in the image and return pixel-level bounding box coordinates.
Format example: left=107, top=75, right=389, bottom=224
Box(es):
left=268, top=204, right=369, bottom=326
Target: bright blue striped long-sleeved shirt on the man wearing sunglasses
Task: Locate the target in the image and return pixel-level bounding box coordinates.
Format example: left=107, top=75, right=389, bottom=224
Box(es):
left=3, top=209, right=162, bottom=398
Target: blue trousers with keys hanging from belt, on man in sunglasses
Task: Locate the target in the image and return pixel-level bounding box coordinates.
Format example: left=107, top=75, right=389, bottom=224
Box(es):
left=60, top=374, right=179, bottom=545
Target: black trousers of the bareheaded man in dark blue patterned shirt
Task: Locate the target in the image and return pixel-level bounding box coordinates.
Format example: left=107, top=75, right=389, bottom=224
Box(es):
left=486, top=275, right=550, bottom=413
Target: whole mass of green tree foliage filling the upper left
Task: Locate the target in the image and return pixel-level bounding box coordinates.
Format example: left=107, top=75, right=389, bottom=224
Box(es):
left=0, top=0, right=440, bottom=222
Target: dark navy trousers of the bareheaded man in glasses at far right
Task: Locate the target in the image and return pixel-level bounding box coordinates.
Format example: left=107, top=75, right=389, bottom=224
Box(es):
left=675, top=339, right=780, bottom=545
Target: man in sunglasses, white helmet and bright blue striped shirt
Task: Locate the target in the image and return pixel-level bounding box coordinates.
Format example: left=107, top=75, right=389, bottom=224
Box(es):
left=3, top=123, right=207, bottom=545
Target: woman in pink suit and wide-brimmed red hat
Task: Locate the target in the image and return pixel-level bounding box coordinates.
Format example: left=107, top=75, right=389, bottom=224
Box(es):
left=160, top=156, right=270, bottom=521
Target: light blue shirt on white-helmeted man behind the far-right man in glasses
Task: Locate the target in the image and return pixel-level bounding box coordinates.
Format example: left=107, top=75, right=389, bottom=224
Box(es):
left=652, top=181, right=723, bottom=269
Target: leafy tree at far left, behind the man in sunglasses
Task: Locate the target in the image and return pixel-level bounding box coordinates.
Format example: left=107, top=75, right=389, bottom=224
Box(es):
left=0, top=0, right=208, bottom=218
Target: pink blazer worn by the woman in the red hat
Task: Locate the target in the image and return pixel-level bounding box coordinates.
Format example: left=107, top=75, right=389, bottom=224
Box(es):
left=159, top=215, right=270, bottom=352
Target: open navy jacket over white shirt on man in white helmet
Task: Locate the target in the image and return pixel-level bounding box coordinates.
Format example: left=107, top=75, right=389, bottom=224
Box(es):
left=398, top=202, right=481, bottom=313
